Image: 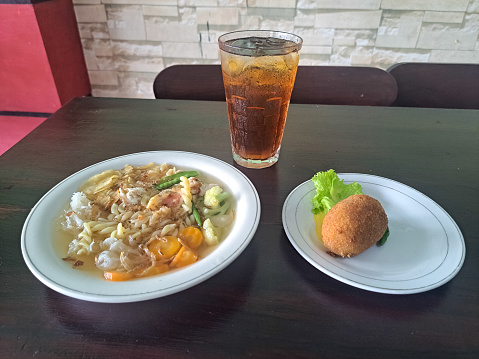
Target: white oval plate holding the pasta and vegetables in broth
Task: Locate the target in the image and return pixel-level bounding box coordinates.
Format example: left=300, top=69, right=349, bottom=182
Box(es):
left=21, top=151, right=261, bottom=303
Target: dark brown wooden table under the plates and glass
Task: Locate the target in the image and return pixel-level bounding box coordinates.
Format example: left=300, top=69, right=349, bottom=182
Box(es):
left=0, top=98, right=479, bottom=358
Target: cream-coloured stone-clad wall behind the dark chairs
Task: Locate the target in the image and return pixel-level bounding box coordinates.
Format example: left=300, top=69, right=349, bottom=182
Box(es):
left=73, top=0, right=479, bottom=98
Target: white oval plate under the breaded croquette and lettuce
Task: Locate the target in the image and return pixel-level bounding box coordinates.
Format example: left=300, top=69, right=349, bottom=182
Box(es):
left=282, top=173, right=466, bottom=294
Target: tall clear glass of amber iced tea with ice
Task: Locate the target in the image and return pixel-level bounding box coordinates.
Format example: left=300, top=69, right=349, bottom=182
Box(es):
left=218, top=30, right=303, bottom=168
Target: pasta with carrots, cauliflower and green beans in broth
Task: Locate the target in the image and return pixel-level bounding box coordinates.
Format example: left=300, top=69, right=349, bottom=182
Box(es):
left=62, top=163, right=234, bottom=280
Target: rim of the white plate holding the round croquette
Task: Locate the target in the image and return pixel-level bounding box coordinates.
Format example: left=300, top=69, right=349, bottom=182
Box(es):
left=282, top=172, right=466, bottom=294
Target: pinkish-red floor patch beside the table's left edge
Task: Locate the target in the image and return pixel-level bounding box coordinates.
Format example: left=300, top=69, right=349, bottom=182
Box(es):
left=0, top=115, right=46, bottom=156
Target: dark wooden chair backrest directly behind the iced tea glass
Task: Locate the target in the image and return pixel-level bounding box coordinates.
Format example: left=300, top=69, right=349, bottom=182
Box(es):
left=153, top=65, right=397, bottom=106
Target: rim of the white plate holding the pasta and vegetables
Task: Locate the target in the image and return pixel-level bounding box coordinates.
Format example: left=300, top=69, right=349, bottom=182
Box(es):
left=20, top=150, right=261, bottom=303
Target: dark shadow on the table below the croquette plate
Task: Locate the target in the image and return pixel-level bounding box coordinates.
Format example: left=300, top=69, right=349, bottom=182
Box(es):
left=282, top=234, right=448, bottom=318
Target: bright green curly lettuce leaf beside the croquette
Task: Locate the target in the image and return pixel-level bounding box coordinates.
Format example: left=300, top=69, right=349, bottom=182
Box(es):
left=311, top=170, right=363, bottom=215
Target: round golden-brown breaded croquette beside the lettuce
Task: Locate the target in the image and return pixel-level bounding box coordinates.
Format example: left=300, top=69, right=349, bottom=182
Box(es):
left=322, top=194, right=388, bottom=257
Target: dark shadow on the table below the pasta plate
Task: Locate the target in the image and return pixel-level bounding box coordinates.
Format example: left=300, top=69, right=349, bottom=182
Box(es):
left=45, top=242, right=256, bottom=344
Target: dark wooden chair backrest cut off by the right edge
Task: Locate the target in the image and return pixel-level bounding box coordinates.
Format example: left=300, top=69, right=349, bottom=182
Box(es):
left=387, top=63, right=479, bottom=109
